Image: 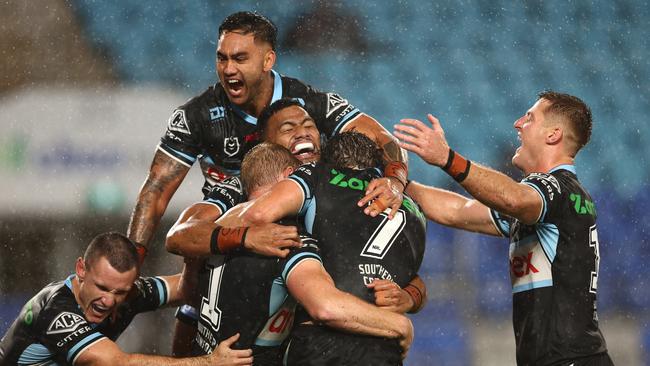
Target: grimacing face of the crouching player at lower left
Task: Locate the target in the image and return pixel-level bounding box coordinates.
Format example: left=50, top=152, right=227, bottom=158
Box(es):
left=76, top=257, right=138, bottom=323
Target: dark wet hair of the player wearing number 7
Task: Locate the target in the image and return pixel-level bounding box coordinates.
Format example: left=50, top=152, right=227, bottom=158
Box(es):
left=322, top=131, right=383, bottom=169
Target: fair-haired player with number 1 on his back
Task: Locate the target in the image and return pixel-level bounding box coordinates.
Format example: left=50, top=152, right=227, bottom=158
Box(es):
left=168, top=143, right=412, bottom=365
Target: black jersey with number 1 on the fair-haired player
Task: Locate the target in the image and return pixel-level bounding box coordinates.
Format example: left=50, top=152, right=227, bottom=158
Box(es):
left=194, top=237, right=321, bottom=364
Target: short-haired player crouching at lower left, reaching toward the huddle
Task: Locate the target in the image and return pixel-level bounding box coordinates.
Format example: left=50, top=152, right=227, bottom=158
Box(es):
left=0, top=233, right=252, bottom=365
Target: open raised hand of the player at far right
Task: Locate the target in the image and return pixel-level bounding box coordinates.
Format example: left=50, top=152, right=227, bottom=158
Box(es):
left=393, top=114, right=449, bottom=167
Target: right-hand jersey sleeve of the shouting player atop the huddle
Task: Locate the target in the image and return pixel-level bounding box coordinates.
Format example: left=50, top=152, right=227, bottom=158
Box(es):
left=305, top=88, right=361, bottom=138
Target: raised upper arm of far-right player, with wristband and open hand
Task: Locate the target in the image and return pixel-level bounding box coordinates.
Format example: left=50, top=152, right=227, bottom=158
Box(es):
left=395, top=114, right=543, bottom=224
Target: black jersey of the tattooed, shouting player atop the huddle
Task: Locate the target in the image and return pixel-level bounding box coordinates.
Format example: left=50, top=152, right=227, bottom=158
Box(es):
left=158, top=71, right=361, bottom=193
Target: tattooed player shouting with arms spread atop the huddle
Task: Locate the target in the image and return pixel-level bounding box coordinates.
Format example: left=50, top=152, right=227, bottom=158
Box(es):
left=128, top=12, right=407, bottom=258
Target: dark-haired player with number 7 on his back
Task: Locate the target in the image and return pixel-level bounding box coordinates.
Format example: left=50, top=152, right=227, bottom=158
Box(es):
left=220, top=132, right=426, bottom=365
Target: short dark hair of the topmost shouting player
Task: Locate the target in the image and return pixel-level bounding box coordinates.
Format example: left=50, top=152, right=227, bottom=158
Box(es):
left=219, top=11, right=278, bottom=51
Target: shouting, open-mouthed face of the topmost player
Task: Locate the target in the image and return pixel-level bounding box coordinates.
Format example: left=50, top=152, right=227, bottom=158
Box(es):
left=217, top=31, right=275, bottom=109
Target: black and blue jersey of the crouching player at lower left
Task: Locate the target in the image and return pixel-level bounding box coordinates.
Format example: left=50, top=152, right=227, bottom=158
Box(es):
left=0, top=275, right=169, bottom=365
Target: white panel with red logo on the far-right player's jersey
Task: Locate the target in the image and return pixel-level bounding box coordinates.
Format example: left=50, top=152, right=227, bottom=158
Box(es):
left=510, top=234, right=553, bottom=293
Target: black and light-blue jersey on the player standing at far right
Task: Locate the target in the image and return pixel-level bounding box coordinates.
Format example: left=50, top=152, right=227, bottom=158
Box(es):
left=491, top=165, right=607, bottom=365
